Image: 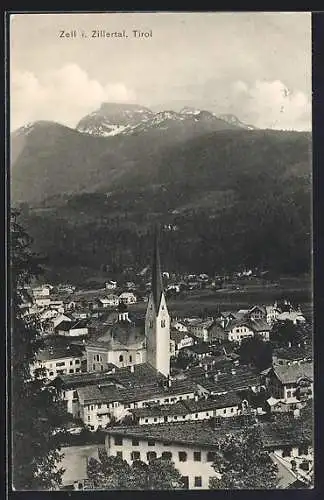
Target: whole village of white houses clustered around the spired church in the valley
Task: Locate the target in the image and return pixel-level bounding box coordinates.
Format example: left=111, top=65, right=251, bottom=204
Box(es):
left=20, top=235, right=313, bottom=490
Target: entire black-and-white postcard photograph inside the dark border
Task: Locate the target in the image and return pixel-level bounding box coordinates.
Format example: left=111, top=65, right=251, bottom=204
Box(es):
left=7, top=11, right=316, bottom=492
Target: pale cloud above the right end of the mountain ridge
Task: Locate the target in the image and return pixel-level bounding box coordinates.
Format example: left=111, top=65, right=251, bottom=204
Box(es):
left=230, top=80, right=311, bottom=130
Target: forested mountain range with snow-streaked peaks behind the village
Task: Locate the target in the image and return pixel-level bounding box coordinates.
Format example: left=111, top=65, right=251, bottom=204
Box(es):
left=11, top=103, right=311, bottom=282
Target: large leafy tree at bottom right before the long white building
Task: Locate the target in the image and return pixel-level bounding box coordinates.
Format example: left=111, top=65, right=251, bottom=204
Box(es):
left=209, top=426, right=278, bottom=490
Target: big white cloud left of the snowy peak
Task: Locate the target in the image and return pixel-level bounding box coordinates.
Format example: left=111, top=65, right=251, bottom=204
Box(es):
left=10, top=64, right=136, bottom=130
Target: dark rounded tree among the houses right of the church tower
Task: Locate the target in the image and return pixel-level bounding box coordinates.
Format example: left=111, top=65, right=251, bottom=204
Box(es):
left=238, top=336, right=272, bottom=370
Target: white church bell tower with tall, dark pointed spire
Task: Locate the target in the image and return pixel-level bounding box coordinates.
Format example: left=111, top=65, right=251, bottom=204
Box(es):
left=145, top=229, right=170, bottom=376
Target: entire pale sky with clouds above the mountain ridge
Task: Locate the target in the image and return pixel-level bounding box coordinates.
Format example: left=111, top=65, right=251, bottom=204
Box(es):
left=10, top=12, right=312, bottom=130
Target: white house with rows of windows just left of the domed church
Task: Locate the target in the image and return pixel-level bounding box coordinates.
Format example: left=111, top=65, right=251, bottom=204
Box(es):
left=31, top=344, right=85, bottom=380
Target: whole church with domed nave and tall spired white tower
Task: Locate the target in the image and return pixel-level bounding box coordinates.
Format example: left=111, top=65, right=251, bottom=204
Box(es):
left=86, top=231, right=170, bottom=377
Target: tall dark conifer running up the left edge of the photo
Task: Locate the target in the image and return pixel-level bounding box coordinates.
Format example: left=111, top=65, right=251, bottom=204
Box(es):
left=10, top=214, right=64, bottom=490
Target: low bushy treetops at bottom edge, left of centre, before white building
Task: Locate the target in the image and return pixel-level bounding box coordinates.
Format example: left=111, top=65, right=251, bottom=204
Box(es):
left=87, top=454, right=183, bottom=490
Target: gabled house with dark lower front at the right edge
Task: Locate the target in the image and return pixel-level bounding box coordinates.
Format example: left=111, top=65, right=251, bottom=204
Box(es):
left=264, top=363, right=314, bottom=402
